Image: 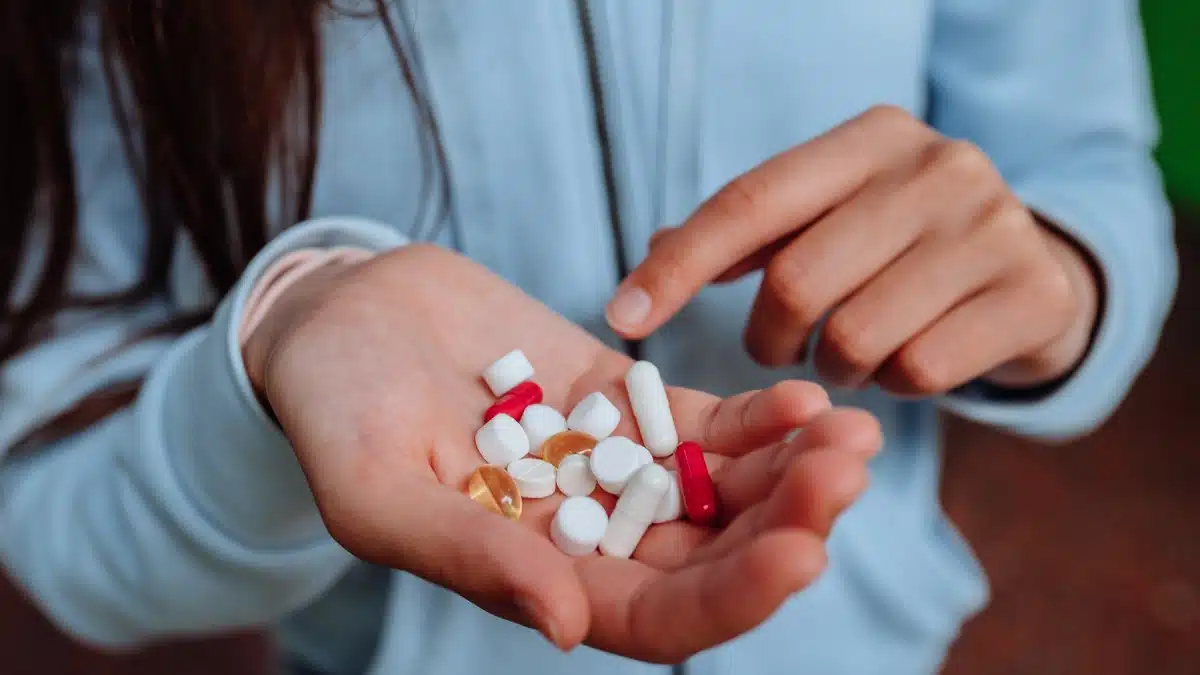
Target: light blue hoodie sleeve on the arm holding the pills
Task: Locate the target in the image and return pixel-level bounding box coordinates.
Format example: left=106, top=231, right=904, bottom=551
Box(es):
left=0, top=13, right=403, bottom=647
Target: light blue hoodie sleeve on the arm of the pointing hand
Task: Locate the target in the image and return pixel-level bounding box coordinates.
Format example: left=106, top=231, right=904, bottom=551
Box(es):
left=930, top=0, right=1177, bottom=440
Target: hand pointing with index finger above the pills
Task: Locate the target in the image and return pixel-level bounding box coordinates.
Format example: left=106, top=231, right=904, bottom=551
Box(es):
left=608, top=102, right=1099, bottom=395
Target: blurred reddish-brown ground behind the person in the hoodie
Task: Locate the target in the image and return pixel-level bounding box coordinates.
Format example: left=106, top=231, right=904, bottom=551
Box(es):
left=0, top=218, right=1200, bottom=675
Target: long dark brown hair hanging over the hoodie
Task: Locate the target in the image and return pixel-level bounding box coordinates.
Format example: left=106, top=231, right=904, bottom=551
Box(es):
left=0, top=0, right=449, bottom=446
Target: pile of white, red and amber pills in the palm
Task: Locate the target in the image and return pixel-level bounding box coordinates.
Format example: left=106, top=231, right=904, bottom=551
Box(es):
left=467, top=350, right=718, bottom=557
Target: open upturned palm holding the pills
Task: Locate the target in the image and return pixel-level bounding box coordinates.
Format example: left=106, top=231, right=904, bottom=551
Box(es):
left=238, top=246, right=881, bottom=662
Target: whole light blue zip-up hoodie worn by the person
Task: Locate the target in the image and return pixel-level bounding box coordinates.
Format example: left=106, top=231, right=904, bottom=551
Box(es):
left=0, top=0, right=1176, bottom=675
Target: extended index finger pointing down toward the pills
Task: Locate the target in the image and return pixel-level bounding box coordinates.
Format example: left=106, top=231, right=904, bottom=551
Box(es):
left=607, top=107, right=934, bottom=340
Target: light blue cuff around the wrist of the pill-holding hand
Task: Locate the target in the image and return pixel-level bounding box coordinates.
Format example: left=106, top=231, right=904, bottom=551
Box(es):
left=159, top=217, right=407, bottom=549
